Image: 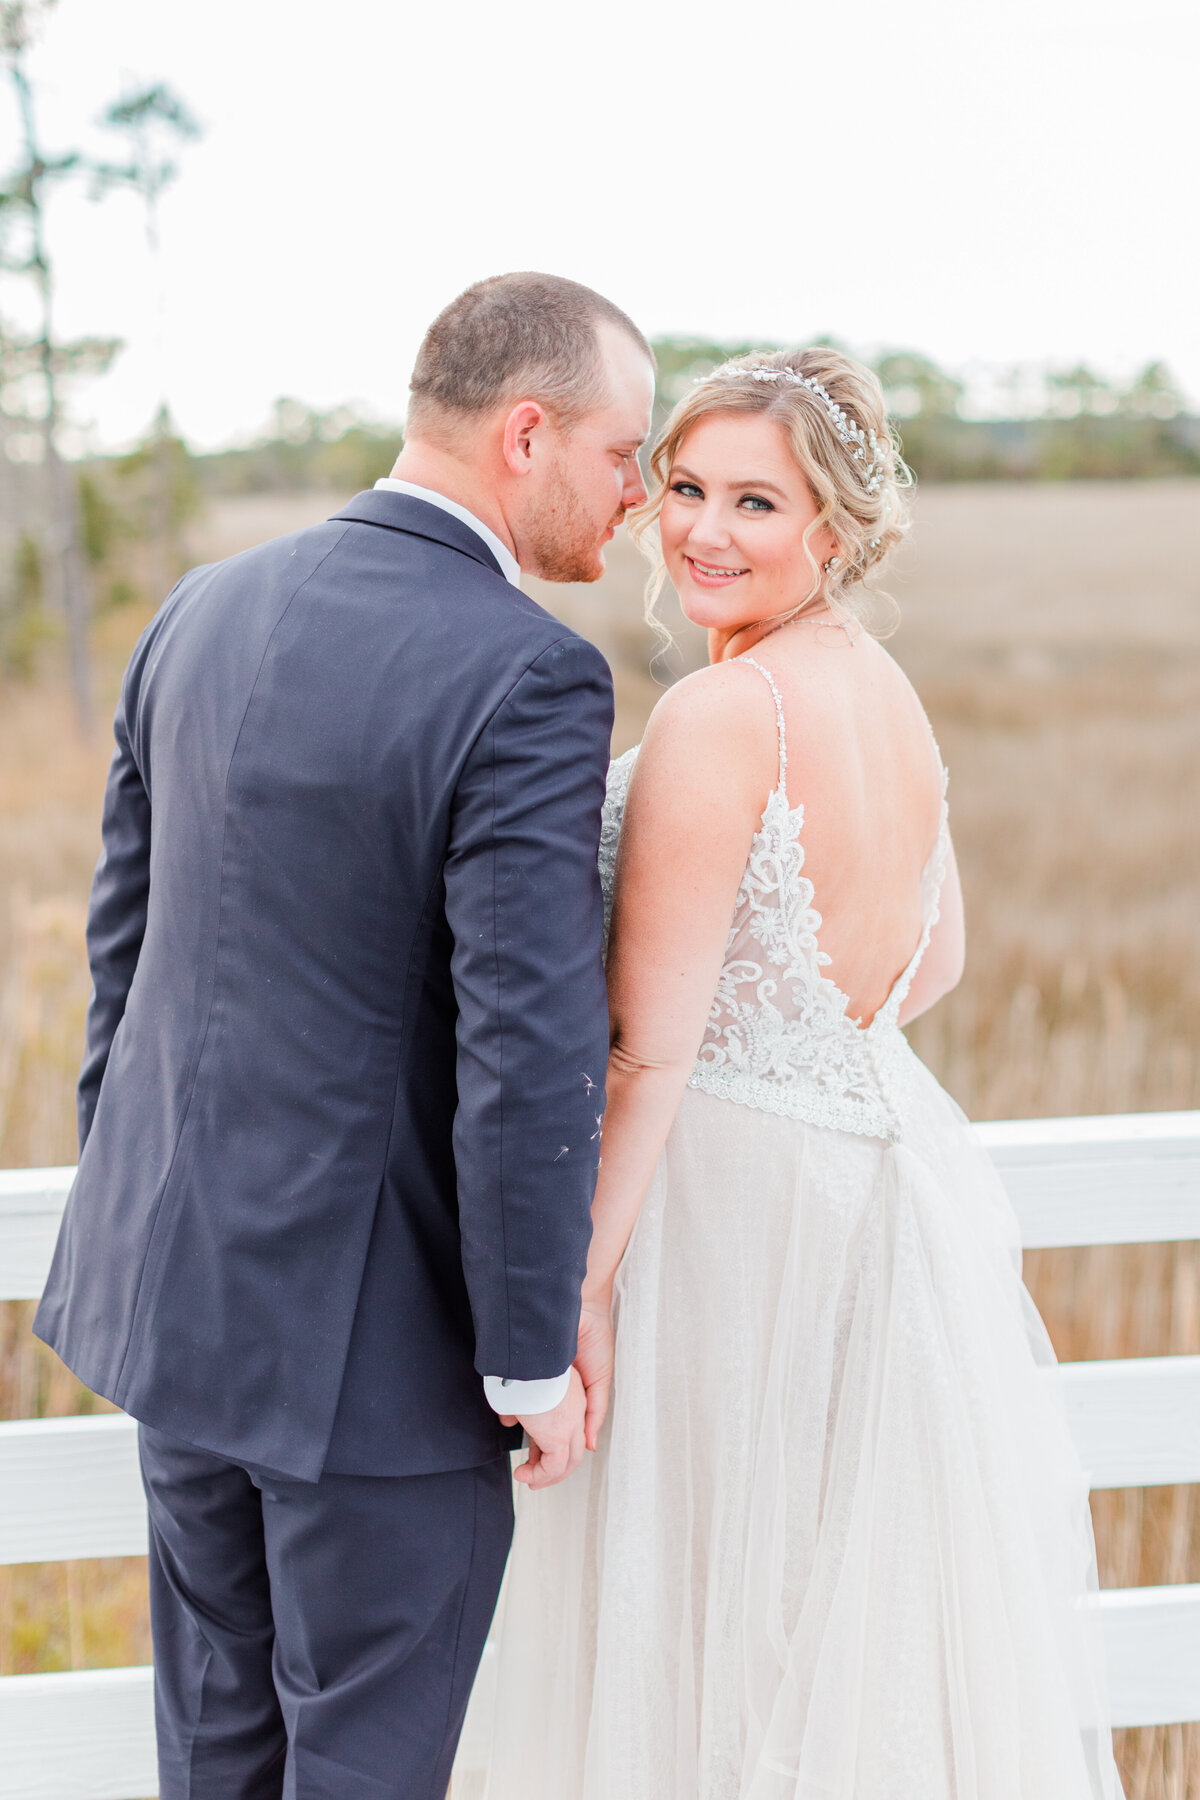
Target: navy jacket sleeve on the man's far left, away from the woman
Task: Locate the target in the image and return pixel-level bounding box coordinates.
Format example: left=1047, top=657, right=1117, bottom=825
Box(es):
left=77, top=682, right=149, bottom=1150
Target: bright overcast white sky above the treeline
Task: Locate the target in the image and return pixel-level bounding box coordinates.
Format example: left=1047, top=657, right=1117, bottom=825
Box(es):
left=0, top=0, right=1200, bottom=446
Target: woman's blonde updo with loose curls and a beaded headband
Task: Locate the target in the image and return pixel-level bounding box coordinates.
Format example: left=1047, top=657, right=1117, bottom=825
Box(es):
left=630, top=346, right=912, bottom=637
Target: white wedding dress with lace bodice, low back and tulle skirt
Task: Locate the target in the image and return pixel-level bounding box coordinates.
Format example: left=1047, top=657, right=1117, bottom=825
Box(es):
left=453, top=657, right=1121, bottom=1800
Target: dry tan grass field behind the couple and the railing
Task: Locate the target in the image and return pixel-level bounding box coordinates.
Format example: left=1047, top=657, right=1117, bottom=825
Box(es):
left=0, top=481, right=1200, bottom=1800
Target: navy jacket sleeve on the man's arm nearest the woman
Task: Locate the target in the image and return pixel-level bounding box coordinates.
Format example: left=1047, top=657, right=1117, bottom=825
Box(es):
left=446, top=637, right=612, bottom=1381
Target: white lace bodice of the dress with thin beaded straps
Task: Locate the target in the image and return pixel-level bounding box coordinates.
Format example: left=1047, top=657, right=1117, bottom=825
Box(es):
left=599, top=657, right=950, bottom=1141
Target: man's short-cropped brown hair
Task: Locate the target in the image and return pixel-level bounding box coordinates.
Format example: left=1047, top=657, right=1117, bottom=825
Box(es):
left=407, top=274, right=655, bottom=437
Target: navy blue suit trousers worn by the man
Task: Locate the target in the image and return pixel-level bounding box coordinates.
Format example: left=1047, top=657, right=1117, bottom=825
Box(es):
left=140, top=1426, right=513, bottom=1800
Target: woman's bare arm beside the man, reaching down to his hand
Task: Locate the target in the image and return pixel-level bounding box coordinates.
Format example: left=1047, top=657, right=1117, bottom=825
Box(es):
left=581, top=664, right=777, bottom=1445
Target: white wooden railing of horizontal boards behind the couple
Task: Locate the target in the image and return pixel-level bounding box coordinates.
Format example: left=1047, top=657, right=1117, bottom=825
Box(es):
left=0, top=1112, right=1200, bottom=1800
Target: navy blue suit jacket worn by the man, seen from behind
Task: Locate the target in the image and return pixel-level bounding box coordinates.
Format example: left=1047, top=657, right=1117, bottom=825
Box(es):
left=36, top=490, right=612, bottom=1480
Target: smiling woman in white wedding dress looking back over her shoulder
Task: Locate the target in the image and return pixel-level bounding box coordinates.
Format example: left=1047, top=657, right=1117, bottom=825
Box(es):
left=467, top=349, right=1121, bottom=1800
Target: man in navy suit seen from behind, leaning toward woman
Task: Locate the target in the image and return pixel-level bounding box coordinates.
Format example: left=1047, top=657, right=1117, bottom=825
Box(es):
left=36, top=275, right=653, bottom=1800
